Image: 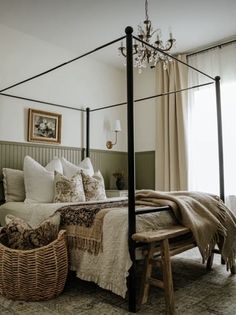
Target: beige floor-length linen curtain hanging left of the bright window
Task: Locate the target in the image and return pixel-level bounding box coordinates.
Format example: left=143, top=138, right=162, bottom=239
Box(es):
left=155, top=55, right=188, bottom=191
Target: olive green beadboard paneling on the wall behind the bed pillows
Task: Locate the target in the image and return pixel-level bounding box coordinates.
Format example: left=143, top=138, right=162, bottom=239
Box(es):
left=0, top=141, right=127, bottom=199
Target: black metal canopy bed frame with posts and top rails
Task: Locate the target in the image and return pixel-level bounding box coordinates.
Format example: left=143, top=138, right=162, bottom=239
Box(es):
left=0, top=26, right=225, bottom=312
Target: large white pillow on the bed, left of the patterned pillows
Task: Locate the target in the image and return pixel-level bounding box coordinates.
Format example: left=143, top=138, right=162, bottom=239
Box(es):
left=23, top=155, right=62, bottom=203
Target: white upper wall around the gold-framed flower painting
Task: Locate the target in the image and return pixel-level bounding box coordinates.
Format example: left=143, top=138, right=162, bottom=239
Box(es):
left=0, top=24, right=126, bottom=151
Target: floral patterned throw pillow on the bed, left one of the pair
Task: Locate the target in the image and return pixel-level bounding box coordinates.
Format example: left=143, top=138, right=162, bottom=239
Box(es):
left=54, top=171, right=85, bottom=202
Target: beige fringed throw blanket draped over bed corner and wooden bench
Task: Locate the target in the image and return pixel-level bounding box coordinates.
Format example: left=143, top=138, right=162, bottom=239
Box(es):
left=136, top=190, right=236, bottom=269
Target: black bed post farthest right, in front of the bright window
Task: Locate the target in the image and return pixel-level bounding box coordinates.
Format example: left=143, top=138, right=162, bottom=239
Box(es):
left=215, top=76, right=225, bottom=201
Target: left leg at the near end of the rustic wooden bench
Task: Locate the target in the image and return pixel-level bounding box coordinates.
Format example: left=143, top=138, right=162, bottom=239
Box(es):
left=138, top=243, right=154, bottom=305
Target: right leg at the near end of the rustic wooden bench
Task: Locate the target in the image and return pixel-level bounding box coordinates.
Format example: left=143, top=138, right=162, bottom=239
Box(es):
left=161, top=239, right=175, bottom=315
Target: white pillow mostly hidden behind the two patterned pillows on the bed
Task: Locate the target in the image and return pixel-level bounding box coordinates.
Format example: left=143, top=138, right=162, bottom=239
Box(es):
left=61, top=157, right=94, bottom=178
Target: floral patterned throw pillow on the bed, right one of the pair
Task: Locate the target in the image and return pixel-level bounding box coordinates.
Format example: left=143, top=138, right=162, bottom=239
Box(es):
left=81, top=171, right=106, bottom=201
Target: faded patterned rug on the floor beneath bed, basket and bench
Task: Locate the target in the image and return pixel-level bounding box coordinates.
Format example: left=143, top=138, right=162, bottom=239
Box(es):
left=0, top=249, right=236, bottom=315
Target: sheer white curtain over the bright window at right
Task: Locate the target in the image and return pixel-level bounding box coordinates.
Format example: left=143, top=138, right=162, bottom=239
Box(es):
left=188, top=43, right=236, bottom=195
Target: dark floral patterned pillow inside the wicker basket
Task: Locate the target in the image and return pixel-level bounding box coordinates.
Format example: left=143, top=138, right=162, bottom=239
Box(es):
left=3, top=213, right=60, bottom=250
